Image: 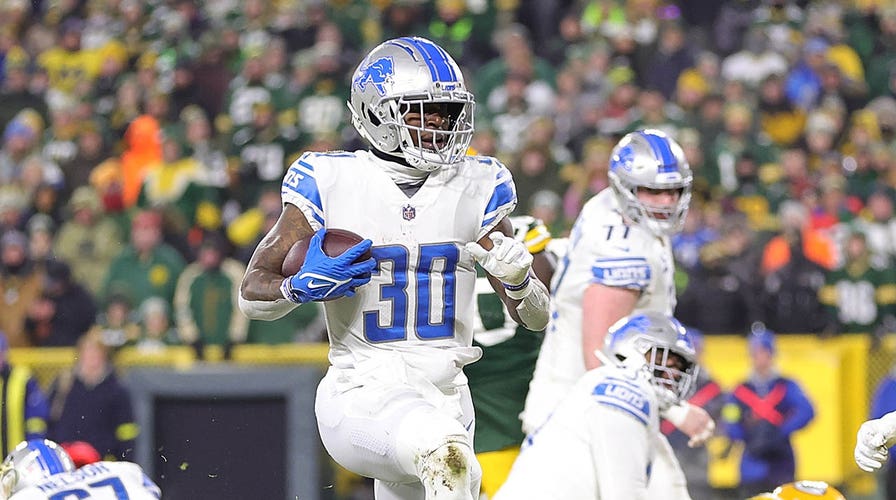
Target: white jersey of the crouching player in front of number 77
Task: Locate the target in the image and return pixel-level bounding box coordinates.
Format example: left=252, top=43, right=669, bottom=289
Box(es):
left=494, top=365, right=689, bottom=500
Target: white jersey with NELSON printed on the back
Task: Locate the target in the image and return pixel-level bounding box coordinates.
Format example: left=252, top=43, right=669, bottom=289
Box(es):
left=10, top=462, right=162, bottom=500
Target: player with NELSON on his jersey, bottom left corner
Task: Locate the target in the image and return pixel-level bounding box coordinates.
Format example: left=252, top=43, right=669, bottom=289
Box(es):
left=0, top=439, right=162, bottom=500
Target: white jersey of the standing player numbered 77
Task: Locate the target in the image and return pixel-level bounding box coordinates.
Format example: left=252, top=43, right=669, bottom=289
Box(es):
left=523, top=188, right=676, bottom=432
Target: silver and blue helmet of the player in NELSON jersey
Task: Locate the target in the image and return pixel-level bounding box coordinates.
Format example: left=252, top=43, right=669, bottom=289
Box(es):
left=0, top=439, right=75, bottom=496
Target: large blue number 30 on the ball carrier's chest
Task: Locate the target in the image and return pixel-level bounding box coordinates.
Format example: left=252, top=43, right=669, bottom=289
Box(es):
left=364, top=243, right=460, bottom=342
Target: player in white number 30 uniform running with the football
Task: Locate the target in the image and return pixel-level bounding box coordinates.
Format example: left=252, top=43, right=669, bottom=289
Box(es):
left=240, top=37, right=548, bottom=500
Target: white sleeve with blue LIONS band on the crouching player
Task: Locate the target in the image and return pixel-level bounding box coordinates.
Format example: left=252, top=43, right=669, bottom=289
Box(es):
left=587, top=379, right=651, bottom=500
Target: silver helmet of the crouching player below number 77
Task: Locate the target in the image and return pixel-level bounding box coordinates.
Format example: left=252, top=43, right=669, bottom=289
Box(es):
left=604, top=312, right=699, bottom=407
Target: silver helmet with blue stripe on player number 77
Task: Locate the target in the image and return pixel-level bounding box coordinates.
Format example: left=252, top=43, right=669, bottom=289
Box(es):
left=607, top=129, right=694, bottom=235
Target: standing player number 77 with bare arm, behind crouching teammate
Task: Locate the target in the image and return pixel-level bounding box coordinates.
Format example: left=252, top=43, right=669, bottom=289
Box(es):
left=523, top=129, right=715, bottom=445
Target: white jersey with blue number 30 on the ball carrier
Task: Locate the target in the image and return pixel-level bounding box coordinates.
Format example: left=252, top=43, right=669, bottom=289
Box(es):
left=281, top=151, right=516, bottom=367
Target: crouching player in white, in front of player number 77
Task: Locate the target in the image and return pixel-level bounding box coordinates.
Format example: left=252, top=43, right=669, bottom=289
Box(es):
left=494, top=312, right=699, bottom=500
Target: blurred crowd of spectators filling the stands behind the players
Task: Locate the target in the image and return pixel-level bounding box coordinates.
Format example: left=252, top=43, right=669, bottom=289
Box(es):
left=0, top=0, right=896, bottom=354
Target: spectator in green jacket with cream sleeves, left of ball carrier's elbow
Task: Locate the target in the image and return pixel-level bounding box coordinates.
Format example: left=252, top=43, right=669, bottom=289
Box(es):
left=174, top=233, right=249, bottom=359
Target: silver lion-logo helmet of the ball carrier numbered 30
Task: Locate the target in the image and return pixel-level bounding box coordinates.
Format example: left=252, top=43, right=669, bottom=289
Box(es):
left=348, top=37, right=475, bottom=172
